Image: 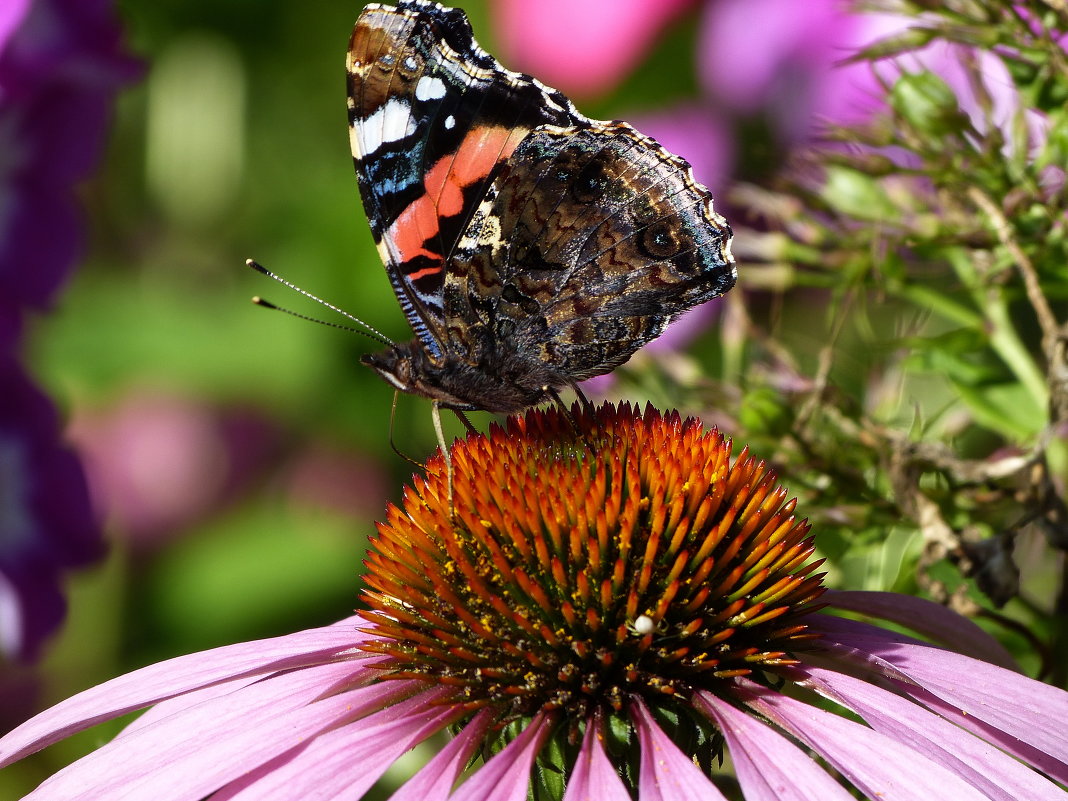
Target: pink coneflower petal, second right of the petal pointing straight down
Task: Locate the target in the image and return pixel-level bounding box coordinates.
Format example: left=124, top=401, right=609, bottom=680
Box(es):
left=694, top=692, right=853, bottom=801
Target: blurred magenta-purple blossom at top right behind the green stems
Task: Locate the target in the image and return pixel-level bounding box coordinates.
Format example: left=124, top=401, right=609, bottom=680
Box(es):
left=697, top=0, right=1059, bottom=150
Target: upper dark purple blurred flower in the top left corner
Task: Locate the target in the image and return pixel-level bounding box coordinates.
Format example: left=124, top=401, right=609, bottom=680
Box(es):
left=0, top=0, right=138, bottom=318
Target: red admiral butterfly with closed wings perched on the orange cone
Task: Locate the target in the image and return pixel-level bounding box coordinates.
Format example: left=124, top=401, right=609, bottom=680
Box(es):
left=347, top=0, right=736, bottom=412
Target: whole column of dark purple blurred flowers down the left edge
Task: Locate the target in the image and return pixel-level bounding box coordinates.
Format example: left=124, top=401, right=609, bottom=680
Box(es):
left=0, top=0, right=137, bottom=659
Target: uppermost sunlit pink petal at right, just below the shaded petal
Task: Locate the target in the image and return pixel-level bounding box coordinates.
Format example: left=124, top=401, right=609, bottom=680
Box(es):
left=802, top=615, right=1068, bottom=782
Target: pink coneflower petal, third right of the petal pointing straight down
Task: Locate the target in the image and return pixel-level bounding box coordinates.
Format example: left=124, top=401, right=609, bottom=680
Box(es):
left=737, top=680, right=988, bottom=801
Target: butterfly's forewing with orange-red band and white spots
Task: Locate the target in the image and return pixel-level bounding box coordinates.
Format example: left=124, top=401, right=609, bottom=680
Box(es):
left=348, top=0, right=587, bottom=349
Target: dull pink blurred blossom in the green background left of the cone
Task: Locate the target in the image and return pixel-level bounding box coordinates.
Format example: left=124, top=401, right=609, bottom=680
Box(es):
left=70, top=389, right=387, bottom=549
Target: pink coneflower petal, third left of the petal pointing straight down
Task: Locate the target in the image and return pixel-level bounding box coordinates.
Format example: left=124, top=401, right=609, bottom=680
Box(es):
left=211, top=691, right=462, bottom=801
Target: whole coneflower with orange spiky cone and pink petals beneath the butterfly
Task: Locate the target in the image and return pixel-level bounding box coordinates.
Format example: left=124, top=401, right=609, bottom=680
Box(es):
left=0, top=406, right=1068, bottom=801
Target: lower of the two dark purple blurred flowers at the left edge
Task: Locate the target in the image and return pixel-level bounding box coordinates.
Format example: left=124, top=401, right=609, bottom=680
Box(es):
left=0, top=356, right=104, bottom=660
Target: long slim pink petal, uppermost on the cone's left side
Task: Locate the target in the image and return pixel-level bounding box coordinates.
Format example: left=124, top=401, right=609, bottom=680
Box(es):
left=0, top=616, right=371, bottom=768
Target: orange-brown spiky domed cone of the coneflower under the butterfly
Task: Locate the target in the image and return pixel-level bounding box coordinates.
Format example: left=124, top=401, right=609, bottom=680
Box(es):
left=364, top=404, right=822, bottom=726
